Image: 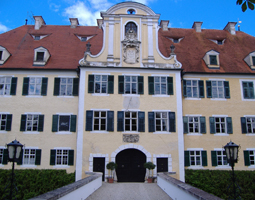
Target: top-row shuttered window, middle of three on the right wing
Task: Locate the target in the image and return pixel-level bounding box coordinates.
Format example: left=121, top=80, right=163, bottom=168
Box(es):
left=206, top=80, right=230, bottom=99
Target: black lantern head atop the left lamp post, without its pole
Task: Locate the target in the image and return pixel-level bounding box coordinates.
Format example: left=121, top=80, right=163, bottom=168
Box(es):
left=7, top=139, right=23, bottom=162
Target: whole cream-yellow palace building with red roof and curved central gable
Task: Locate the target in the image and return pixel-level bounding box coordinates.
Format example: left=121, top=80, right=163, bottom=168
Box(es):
left=0, top=2, right=255, bottom=182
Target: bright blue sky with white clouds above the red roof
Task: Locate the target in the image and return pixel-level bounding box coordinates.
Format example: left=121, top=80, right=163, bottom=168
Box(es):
left=0, top=0, right=255, bottom=36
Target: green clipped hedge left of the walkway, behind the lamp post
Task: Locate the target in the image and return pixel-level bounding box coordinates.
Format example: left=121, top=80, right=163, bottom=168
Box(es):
left=0, top=169, right=75, bottom=200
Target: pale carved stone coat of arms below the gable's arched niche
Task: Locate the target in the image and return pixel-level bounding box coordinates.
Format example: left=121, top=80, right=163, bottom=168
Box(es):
left=121, top=29, right=141, bottom=64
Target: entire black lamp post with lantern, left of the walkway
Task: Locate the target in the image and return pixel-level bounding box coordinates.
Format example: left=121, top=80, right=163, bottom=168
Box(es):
left=7, top=139, right=23, bottom=200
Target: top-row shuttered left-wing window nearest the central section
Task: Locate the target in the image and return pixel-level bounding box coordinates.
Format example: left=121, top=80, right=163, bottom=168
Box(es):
left=53, top=77, right=79, bottom=96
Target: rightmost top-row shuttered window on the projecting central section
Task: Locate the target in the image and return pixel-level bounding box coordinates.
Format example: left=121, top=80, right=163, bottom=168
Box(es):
left=148, top=76, right=174, bottom=95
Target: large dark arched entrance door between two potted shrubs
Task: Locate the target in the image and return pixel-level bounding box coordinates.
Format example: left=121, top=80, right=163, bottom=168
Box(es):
left=116, top=149, right=146, bottom=182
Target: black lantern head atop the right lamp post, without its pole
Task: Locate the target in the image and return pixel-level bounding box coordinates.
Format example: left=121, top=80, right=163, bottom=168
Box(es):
left=224, top=141, right=240, bottom=166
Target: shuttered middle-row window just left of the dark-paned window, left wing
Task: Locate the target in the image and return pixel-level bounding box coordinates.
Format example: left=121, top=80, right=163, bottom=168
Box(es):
left=20, top=114, right=44, bottom=132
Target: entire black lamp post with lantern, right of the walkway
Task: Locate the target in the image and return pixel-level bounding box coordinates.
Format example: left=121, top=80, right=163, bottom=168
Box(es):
left=224, top=141, right=240, bottom=199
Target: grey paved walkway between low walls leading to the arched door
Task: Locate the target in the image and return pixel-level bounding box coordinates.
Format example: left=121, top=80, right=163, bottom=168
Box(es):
left=86, top=182, right=172, bottom=200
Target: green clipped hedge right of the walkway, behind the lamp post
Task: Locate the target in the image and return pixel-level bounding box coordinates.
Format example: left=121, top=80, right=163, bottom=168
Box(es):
left=185, top=169, right=255, bottom=200
